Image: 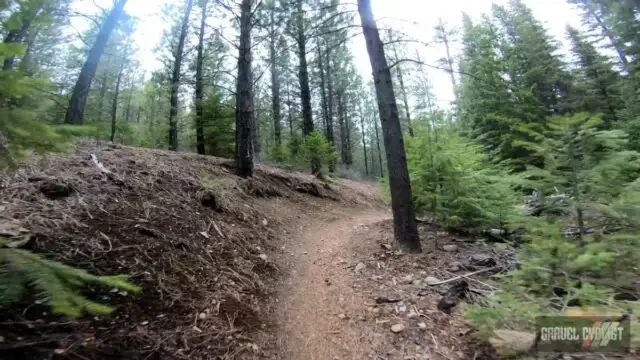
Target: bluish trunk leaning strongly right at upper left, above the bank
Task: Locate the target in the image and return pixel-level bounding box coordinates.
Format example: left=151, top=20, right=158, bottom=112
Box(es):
left=64, top=0, right=127, bottom=125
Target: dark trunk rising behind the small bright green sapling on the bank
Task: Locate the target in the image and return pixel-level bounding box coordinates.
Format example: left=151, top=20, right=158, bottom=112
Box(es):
left=296, top=0, right=320, bottom=175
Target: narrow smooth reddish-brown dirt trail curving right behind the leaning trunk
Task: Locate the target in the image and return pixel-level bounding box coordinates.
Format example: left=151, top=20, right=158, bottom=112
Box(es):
left=279, top=209, right=391, bottom=360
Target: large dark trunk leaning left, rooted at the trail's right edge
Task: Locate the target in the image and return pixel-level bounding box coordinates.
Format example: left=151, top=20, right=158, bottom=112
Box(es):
left=358, top=0, right=422, bottom=253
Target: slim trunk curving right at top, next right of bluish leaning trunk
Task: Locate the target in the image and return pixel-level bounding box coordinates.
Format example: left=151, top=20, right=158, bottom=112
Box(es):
left=169, top=0, right=193, bottom=151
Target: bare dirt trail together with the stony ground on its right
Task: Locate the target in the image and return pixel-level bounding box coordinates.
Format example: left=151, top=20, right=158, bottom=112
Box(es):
left=266, top=214, right=504, bottom=360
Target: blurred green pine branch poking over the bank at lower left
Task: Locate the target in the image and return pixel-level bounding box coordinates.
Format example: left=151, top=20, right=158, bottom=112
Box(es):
left=0, top=238, right=140, bottom=318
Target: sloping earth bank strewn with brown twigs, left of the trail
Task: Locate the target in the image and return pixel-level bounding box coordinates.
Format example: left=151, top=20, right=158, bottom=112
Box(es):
left=0, top=143, right=373, bottom=359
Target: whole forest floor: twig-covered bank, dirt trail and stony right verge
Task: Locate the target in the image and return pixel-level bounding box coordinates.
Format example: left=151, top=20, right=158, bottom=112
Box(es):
left=0, top=143, right=504, bottom=360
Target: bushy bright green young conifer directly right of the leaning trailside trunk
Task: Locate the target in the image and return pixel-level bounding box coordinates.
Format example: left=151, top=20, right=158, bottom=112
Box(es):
left=407, top=125, right=518, bottom=229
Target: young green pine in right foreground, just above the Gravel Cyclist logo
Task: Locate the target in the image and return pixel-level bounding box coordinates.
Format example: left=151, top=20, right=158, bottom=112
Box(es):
left=467, top=113, right=640, bottom=337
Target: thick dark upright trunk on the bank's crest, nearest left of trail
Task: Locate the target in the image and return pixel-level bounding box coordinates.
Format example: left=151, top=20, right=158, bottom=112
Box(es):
left=235, top=0, right=254, bottom=177
